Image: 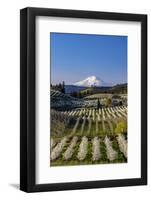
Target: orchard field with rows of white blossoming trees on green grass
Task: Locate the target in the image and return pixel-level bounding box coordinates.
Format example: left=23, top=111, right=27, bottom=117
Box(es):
left=50, top=106, right=127, bottom=166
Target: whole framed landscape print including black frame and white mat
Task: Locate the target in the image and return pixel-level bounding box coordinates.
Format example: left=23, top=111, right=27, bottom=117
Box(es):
left=20, top=8, right=147, bottom=192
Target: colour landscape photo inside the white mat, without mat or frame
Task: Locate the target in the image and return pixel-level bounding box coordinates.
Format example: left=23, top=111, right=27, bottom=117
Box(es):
left=50, top=33, right=128, bottom=167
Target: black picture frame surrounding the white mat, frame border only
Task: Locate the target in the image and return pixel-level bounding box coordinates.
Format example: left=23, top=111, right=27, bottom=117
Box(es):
left=20, top=7, right=147, bottom=192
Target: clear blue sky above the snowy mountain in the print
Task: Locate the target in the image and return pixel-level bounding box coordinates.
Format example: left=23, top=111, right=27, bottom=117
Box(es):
left=50, top=33, right=127, bottom=84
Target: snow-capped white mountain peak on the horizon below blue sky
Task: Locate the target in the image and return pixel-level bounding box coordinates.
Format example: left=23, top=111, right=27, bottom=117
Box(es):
left=73, top=76, right=112, bottom=87
